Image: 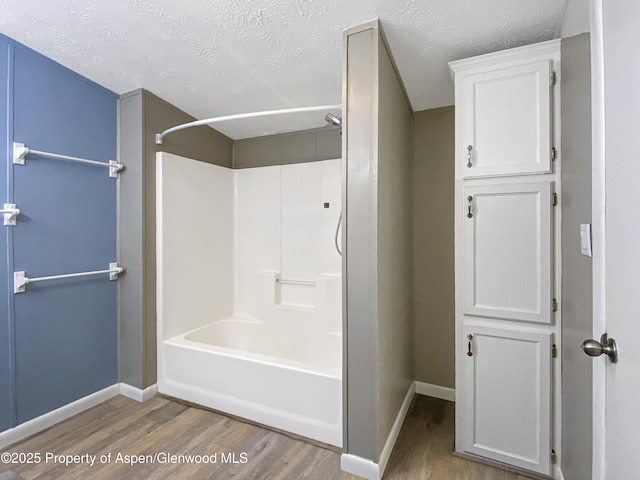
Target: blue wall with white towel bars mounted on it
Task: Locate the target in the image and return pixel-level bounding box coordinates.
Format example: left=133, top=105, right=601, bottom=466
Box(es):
left=0, top=36, right=117, bottom=430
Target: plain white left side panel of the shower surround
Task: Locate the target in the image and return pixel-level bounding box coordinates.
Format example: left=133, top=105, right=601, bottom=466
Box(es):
left=157, top=152, right=233, bottom=341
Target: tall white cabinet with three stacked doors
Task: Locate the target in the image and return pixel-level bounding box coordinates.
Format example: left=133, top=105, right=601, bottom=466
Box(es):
left=450, top=41, right=561, bottom=477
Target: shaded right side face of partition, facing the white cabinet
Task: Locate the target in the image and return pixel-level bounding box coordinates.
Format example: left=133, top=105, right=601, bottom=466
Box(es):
left=377, top=31, right=414, bottom=455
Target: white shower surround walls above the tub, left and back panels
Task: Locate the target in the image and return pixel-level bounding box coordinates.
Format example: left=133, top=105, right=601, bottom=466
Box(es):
left=157, top=153, right=341, bottom=341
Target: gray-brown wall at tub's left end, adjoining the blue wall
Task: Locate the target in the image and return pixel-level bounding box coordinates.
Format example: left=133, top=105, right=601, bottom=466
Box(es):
left=118, top=90, right=233, bottom=388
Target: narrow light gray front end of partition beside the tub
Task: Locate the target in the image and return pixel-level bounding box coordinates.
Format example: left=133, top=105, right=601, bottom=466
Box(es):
left=342, top=23, right=378, bottom=461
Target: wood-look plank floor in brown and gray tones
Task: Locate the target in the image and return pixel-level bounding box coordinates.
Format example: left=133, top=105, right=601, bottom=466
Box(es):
left=0, top=395, right=526, bottom=480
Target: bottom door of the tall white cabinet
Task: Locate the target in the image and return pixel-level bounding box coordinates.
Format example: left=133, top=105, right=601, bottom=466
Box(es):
left=463, top=325, right=551, bottom=475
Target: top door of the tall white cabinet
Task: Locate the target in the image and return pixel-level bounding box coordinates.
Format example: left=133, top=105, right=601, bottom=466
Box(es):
left=458, top=61, right=551, bottom=178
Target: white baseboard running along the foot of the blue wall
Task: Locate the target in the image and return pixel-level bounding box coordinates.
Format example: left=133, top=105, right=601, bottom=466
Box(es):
left=0, top=384, right=120, bottom=448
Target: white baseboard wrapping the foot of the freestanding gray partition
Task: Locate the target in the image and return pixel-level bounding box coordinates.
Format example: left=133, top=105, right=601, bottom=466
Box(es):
left=340, top=382, right=416, bottom=480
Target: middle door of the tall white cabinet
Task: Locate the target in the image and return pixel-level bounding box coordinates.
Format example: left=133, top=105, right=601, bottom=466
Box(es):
left=460, top=182, right=552, bottom=324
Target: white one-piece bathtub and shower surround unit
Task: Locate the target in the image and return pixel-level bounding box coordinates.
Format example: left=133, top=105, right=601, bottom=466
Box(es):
left=157, top=153, right=342, bottom=446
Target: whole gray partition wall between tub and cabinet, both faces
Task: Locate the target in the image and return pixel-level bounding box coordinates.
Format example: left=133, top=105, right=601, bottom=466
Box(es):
left=342, top=21, right=413, bottom=462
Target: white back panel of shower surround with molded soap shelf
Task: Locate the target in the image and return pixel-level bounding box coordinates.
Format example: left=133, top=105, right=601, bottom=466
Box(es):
left=234, top=160, right=341, bottom=320
